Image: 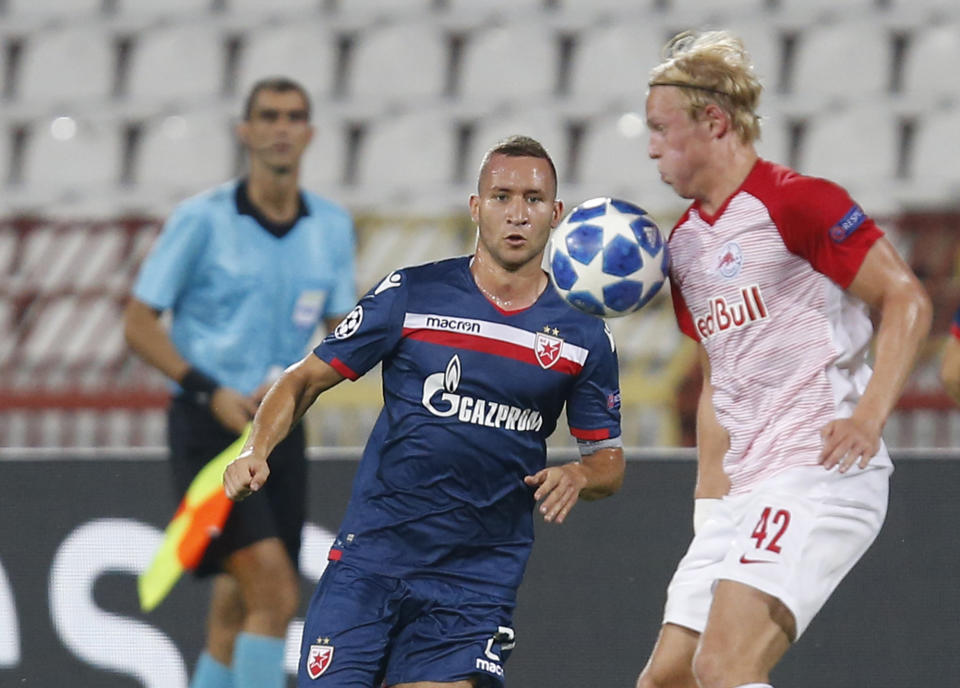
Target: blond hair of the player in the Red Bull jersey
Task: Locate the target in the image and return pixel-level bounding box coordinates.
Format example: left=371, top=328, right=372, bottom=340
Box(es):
left=649, top=31, right=763, bottom=143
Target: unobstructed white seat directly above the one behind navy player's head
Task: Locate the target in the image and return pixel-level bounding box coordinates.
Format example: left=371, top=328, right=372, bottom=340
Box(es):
left=458, top=22, right=560, bottom=108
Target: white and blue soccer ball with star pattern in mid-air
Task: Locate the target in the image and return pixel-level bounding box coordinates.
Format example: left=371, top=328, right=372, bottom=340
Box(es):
left=547, top=198, right=670, bottom=318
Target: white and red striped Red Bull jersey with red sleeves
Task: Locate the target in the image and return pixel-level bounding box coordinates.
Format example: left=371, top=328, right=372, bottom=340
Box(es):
left=670, top=160, right=889, bottom=494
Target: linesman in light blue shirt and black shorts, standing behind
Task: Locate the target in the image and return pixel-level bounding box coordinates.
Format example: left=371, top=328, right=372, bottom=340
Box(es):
left=125, top=78, right=356, bottom=688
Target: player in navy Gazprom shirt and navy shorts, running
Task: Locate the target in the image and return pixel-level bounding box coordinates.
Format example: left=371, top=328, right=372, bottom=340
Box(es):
left=224, top=137, right=624, bottom=688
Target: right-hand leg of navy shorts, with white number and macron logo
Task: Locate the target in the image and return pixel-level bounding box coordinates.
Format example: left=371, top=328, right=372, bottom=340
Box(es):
left=386, top=581, right=516, bottom=687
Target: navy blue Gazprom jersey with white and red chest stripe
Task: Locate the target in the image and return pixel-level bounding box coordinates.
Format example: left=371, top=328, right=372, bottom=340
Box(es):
left=315, top=257, right=620, bottom=598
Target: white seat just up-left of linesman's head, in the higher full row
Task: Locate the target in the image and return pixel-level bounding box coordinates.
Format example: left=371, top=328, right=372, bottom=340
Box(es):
left=125, top=23, right=226, bottom=109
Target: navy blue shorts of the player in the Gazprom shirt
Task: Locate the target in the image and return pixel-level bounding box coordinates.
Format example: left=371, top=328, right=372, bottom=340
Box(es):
left=297, top=561, right=515, bottom=688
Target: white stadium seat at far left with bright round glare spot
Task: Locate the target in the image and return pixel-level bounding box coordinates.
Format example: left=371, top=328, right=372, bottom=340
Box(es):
left=12, top=118, right=124, bottom=202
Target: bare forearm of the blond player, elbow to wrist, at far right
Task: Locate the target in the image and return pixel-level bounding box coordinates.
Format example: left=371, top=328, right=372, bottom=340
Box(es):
left=853, top=284, right=933, bottom=428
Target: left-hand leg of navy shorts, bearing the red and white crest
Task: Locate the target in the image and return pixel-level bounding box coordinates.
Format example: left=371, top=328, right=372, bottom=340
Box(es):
left=297, top=562, right=406, bottom=688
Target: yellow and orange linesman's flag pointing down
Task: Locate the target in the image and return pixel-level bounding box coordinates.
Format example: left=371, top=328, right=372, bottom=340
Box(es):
left=137, top=423, right=251, bottom=612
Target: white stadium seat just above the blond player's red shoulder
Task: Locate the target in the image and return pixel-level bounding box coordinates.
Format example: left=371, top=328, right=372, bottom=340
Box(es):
left=798, top=104, right=901, bottom=213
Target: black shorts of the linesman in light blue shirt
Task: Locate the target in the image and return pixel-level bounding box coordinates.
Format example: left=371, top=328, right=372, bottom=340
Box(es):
left=167, top=395, right=307, bottom=577
